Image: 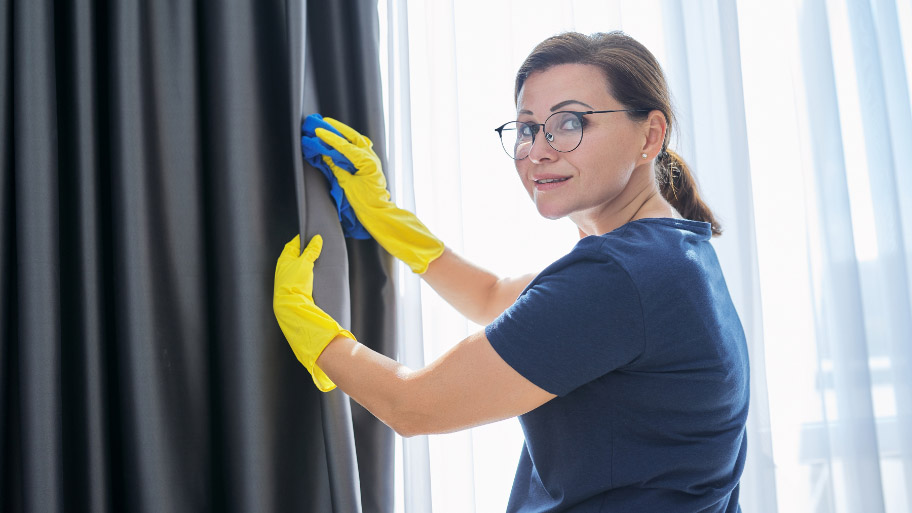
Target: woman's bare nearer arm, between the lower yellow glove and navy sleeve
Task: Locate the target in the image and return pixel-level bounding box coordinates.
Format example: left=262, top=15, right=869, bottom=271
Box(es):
left=317, top=332, right=555, bottom=436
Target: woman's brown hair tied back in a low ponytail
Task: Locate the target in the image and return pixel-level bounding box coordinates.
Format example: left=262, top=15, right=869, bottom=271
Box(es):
left=514, top=31, right=722, bottom=235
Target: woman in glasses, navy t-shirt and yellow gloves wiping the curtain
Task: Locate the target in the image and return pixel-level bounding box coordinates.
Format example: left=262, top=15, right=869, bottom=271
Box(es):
left=275, top=32, right=748, bottom=512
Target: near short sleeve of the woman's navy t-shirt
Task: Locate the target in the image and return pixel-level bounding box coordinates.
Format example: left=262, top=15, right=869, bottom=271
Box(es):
left=485, top=255, right=645, bottom=396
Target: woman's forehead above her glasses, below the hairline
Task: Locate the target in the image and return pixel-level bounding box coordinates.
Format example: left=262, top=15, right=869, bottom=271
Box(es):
left=516, top=64, right=617, bottom=115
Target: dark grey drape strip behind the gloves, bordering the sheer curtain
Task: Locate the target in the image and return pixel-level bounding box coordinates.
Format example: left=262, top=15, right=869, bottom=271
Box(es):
left=307, top=0, right=396, bottom=511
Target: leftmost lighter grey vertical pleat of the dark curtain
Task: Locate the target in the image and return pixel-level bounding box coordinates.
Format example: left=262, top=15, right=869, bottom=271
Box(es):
left=13, top=2, right=64, bottom=511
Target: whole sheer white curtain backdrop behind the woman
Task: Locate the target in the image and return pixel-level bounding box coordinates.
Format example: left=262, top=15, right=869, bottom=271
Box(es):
left=380, top=0, right=912, bottom=513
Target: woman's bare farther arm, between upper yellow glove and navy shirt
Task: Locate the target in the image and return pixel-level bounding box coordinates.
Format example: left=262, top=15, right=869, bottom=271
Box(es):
left=421, top=248, right=535, bottom=326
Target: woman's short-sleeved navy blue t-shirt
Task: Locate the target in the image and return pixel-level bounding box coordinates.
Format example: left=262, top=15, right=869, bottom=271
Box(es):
left=485, top=219, right=748, bottom=513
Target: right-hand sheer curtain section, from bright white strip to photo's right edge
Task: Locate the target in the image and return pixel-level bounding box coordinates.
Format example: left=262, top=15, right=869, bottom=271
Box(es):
left=739, top=0, right=912, bottom=512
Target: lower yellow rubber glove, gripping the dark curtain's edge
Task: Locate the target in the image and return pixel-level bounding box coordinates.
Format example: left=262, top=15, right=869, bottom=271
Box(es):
left=272, top=235, right=355, bottom=392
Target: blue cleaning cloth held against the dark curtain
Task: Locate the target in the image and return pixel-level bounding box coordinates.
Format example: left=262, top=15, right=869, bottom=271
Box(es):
left=301, top=114, right=370, bottom=239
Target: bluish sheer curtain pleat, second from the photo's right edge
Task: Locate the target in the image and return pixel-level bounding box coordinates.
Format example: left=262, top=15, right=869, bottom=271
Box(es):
left=799, top=1, right=884, bottom=512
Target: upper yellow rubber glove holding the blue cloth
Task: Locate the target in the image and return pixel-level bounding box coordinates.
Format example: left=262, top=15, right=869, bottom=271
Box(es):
left=314, top=118, right=444, bottom=274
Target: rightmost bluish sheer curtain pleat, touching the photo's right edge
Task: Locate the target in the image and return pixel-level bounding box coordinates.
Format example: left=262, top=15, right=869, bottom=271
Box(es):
left=847, top=1, right=912, bottom=511
